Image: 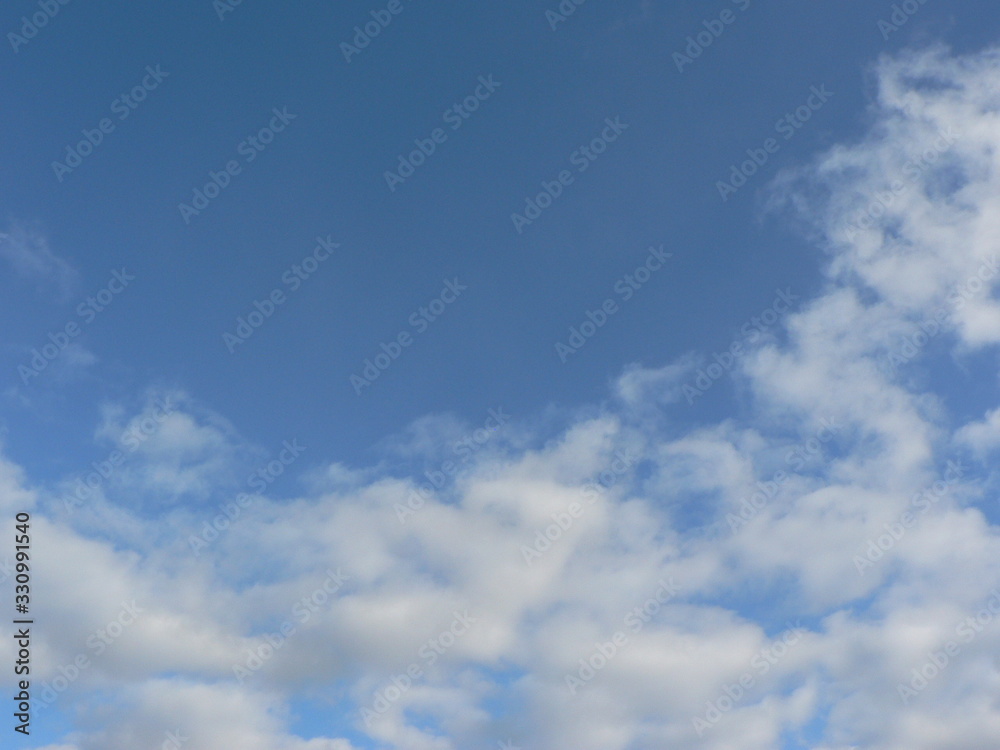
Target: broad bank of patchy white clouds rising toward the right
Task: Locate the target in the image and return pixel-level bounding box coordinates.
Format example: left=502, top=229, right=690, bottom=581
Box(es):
left=0, top=41, right=1000, bottom=750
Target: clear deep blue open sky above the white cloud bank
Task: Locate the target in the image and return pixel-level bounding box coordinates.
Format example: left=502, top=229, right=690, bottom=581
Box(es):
left=9, top=2, right=993, bottom=470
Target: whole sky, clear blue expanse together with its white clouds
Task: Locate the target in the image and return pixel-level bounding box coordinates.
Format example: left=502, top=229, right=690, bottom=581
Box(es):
left=0, top=0, right=1000, bottom=750
